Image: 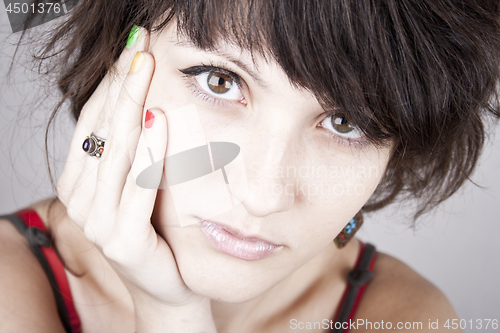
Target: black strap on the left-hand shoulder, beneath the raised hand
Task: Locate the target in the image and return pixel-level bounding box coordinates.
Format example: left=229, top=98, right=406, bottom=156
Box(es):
left=0, top=214, right=72, bottom=333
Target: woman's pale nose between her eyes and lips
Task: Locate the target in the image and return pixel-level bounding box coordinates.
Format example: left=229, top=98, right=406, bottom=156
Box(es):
left=242, top=123, right=297, bottom=217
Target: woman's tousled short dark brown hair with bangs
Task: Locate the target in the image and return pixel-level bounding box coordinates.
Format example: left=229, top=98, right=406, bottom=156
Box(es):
left=26, top=0, right=500, bottom=222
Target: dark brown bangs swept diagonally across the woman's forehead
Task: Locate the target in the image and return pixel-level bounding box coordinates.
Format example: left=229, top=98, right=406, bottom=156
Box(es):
left=154, top=0, right=395, bottom=144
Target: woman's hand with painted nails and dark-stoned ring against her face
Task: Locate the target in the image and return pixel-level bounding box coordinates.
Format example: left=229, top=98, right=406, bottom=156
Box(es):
left=57, top=28, right=215, bottom=328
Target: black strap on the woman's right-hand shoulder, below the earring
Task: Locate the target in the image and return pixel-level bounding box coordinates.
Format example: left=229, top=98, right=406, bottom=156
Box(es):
left=331, top=243, right=376, bottom=333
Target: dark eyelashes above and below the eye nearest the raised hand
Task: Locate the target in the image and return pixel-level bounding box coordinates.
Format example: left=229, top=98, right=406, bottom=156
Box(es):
left=179, top=64, right=242, bottom=107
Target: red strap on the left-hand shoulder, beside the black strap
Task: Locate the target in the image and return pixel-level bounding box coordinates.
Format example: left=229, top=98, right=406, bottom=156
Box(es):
left=15, top=209, right=82, bottom=333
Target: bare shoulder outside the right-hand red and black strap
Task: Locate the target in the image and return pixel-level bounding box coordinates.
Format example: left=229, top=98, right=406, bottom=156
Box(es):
left=356, top=252, right=461, bottom=332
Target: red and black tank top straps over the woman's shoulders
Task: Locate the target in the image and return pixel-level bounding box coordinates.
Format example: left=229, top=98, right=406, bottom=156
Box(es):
left=0, top=209, right=376, bottom=333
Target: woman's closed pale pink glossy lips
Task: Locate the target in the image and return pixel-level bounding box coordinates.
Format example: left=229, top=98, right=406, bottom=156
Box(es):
left=199, top=220, right=283, bottom=261
